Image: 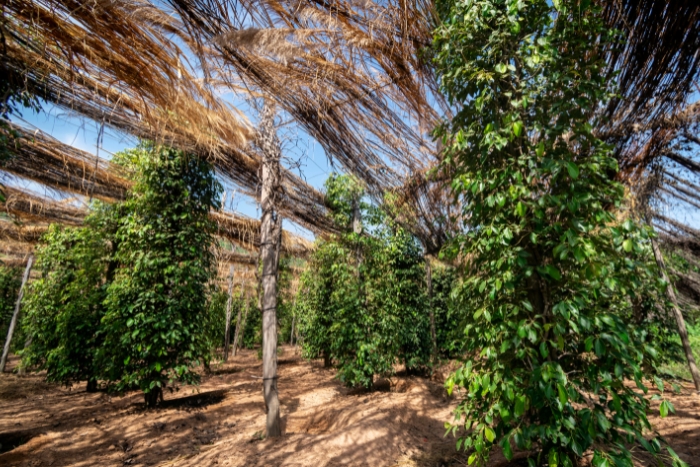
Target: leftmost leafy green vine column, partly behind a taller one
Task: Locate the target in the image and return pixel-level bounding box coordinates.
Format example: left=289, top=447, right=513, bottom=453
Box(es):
left=23, top=217, right=110, bottom=389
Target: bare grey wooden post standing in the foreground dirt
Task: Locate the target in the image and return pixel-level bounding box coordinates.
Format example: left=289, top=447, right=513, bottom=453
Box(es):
left=259, top=103, right=282, bottom=438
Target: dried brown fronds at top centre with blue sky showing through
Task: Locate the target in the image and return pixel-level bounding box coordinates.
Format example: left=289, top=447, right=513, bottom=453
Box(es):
left=163, top=0, right=445, bottom=238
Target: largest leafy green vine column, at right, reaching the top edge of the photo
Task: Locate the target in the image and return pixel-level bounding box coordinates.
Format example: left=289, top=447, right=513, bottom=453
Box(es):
left=434, top=0, right=684, bottom=466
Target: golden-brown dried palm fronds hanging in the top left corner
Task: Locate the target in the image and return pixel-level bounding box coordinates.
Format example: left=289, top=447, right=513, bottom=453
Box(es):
left=2, top=0, right=252, bottom=152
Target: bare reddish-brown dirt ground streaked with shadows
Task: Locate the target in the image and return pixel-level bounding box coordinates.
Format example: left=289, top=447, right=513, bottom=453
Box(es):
left=0, top=348, right=700, bottom=467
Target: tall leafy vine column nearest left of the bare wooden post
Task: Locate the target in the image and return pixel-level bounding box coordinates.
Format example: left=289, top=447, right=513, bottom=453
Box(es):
left=101, top=147, right=220, bottom=404
